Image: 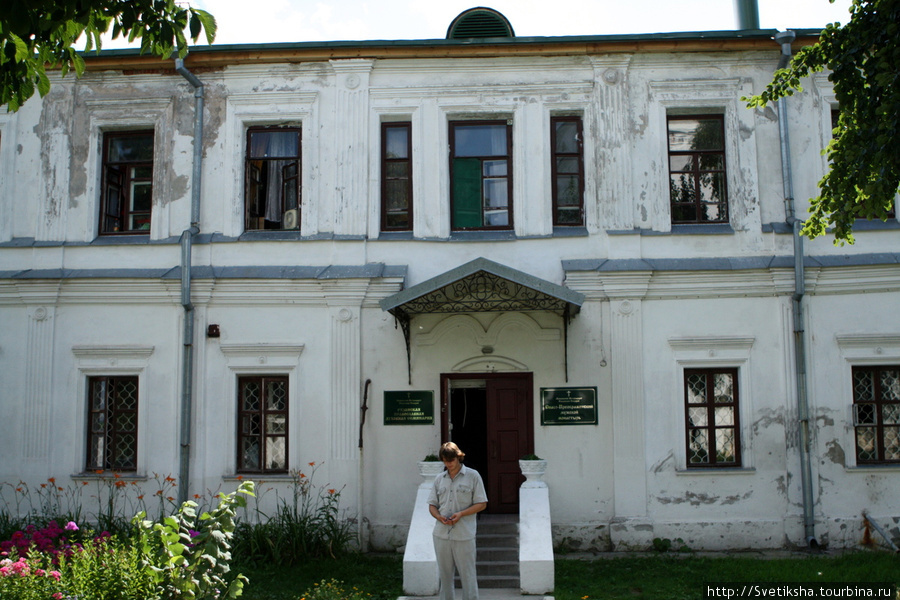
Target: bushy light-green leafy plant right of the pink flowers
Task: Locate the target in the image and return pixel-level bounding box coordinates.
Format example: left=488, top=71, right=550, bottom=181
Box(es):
left=135, top=481, right=254, bottom=600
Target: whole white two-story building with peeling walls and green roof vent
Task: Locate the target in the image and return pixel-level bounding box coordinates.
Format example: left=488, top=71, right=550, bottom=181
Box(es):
left=0, top=9, right=900, bottom=550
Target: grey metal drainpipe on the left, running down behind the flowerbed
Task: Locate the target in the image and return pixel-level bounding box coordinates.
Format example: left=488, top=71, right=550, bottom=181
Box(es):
left=175, top=58, right=203, bottom=503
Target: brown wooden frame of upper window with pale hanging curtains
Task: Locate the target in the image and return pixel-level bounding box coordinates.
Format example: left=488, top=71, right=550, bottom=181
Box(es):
left=244, top=125, right=303, bottom=231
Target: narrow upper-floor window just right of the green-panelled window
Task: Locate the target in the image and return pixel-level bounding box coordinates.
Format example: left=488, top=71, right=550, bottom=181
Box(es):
left=550, top=117, right=584, bottom=226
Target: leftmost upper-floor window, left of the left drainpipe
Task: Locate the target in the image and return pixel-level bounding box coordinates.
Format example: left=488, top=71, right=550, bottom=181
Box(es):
left=100, top=131, right=153, bottom=234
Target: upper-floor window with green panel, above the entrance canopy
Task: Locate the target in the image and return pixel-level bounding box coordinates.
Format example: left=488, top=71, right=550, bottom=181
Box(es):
left=450, top=121, right=513, bottom=231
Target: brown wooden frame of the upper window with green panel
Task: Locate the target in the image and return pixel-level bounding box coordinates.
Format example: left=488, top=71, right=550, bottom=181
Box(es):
left=448, top=119, right=514, bottom=231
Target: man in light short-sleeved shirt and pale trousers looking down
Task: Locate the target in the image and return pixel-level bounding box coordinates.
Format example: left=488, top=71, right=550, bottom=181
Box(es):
left=428, top=442, right=487, bottom=600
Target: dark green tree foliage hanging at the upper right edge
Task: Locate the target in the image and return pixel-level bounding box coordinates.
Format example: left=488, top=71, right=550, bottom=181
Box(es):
left=745, top=0, right=900, bottom=244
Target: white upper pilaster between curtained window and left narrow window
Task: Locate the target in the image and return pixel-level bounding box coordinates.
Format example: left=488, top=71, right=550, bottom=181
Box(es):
left=331, top=59, right=375, bottom=235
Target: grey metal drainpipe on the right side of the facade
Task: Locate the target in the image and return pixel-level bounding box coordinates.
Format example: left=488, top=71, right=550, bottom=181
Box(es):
left=775, top=31, right=819, bottom=548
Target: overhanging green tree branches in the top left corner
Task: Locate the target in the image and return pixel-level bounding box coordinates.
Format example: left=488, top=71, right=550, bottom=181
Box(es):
left=0, top=0, right=216, bottom=111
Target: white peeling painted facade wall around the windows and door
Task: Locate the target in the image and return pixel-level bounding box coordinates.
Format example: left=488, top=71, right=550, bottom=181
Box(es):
left=0, top=18, right=900, bottom=550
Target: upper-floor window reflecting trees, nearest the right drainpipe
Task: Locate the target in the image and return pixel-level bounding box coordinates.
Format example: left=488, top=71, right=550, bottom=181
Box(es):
left=667, top=114, right=728, bottom=223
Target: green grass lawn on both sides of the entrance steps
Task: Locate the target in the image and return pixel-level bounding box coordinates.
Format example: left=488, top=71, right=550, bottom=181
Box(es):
left=235, top=551, right=900, bottom=600
